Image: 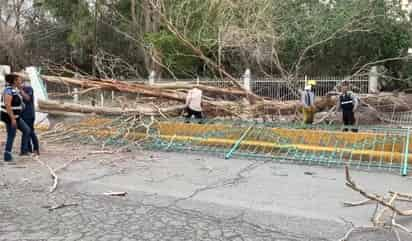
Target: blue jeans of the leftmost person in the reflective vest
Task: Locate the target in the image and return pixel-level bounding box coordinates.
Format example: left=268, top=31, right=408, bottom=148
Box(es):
left=4, top=119, right=31, bottom=161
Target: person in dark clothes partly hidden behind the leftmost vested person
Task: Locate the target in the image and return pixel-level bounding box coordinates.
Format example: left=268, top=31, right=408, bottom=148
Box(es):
left=20, top=81, right=40, bottom=155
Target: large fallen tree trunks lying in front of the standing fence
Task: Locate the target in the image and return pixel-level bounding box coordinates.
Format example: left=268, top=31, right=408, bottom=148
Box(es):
left=21, top=75, right=410, bottom=118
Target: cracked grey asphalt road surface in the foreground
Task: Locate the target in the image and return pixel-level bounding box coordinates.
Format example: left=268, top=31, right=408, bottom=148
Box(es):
left=0, top=144, right=412, bottom=241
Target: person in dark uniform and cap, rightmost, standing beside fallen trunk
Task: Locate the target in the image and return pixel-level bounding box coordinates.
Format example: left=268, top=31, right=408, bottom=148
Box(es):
left=336, top=81, right=359, bottom=132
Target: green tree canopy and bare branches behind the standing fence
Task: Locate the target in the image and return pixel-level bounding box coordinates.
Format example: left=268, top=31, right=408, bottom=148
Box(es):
left=0, top=0, right=412, bottom=85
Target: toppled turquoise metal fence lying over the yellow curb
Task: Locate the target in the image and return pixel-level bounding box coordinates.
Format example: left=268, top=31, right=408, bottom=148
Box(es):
left=42, top=117, right=412, bottom=175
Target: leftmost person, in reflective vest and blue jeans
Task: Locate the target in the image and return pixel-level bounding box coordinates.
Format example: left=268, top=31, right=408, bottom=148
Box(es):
left=0, top=74, right=30, bottom=162
